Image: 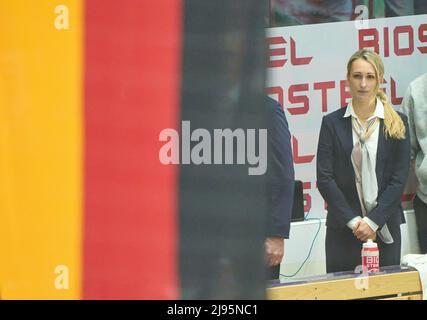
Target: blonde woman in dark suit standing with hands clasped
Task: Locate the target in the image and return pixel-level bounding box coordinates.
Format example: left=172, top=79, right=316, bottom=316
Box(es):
left=317, top=49, right=410, bottom=272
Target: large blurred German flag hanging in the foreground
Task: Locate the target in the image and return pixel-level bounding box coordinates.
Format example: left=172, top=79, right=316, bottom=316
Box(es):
left=0, top=0, right=267, bottom=299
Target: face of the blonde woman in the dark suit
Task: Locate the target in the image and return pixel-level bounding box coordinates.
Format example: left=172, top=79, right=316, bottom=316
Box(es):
left=347, top=58, right=377, bottom=102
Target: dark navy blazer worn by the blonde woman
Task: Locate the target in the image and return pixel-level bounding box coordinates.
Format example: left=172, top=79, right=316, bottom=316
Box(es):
left=317, top=108, right=410, bottom=228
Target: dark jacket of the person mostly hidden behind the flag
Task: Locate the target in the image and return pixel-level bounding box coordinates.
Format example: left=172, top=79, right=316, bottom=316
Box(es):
left=266, top=97, right=295, bottom=239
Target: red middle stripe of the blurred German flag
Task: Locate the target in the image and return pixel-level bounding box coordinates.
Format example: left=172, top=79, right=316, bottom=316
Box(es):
left=83, top=0, right=181, bottom=299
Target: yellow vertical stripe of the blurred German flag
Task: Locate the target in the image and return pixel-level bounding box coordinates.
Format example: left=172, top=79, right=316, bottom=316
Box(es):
left=0, top=0, right=84, bottom=299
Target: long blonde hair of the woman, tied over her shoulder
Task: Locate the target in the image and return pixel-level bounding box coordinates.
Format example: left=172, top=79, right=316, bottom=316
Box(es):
left=347, top=49, right=406, bottom=139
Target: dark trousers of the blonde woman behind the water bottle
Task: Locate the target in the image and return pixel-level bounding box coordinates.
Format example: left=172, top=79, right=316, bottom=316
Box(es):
left=325, top=226, right=401, bottom=273
